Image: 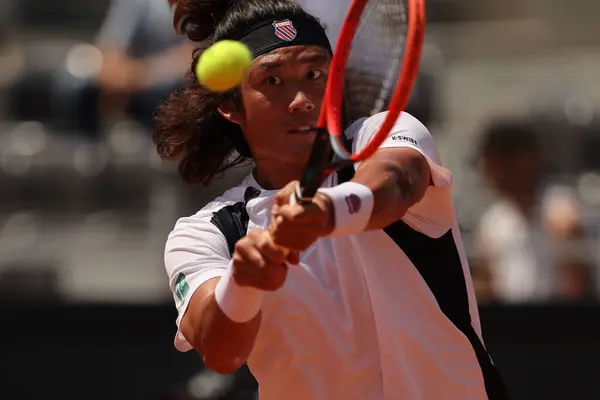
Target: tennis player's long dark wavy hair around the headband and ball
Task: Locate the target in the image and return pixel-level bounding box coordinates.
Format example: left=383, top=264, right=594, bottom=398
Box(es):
left=154, top=0, right=316, bottom=185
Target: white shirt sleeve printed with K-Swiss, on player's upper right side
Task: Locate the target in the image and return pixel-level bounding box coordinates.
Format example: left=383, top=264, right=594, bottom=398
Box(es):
left=346, top=112, right=455, bottom=238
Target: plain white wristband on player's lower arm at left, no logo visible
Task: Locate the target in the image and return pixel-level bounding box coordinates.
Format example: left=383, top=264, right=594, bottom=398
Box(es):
left=215, top=263, right=264, bottom=323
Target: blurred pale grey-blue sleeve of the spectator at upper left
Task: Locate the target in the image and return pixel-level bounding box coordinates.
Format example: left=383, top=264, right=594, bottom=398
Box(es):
left=96, top=0, right=146, bottom=51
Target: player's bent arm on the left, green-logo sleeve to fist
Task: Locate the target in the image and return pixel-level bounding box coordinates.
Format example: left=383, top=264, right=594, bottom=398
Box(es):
left=165, top=219, right=297, bottom=374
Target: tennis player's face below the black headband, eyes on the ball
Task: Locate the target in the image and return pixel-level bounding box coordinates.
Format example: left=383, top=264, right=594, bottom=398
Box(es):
left=234, top=46, right=331, bottom=168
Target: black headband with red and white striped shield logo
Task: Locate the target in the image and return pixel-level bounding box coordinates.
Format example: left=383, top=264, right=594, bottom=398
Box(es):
left=233, top=16, right=333, bottom=58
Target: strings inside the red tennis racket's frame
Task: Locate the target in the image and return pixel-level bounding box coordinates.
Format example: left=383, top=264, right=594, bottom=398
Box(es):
left=344, top=0, right=408, bottom=123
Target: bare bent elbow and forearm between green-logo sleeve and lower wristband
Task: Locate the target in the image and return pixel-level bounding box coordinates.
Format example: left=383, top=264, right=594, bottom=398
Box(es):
left=181, top=278, right=261, bottom=374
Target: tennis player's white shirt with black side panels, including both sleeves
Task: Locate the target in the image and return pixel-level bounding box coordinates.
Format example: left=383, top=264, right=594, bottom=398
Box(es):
left=165, top=113, right=505, bottom=400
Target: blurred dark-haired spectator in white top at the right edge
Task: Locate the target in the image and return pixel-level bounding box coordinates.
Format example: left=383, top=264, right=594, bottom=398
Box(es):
left=474, top=121, right=591, bottom=302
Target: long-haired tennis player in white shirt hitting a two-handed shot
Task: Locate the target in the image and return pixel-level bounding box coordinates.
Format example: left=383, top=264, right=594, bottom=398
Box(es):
left=155, top=0, right=507, bottom=400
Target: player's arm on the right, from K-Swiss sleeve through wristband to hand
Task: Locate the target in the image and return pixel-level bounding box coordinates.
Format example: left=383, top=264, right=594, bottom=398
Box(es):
left=270, top=113, right=454, bottom=250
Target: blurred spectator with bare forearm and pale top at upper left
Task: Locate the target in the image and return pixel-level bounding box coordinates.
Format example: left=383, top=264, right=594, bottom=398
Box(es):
left=59, top=0, right=193, bottom=134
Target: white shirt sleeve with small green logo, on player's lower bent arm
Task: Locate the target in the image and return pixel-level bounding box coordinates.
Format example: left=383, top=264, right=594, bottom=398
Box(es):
left=165, top=212, right=231, bottom=351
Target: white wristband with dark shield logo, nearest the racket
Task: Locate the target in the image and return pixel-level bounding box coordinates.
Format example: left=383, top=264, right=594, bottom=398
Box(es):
left=319, top=182, right=374, bottom=237
